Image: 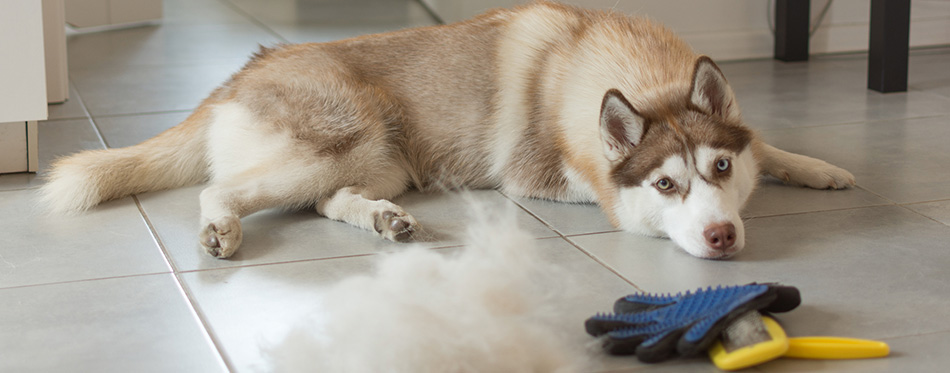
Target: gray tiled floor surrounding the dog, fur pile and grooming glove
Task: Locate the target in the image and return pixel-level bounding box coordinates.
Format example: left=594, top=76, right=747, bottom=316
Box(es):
left=0, top=0, right=950, bottom=372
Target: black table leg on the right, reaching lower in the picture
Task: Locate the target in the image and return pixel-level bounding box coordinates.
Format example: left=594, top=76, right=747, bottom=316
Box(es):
left=868, top=0, right=910, bottom=93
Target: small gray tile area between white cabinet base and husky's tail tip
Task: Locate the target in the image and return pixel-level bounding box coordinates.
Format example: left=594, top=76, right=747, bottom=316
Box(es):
left=0, top=118, right=103, bottom=191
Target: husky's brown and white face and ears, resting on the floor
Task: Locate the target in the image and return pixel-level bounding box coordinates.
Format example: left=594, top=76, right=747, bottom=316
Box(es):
left=600, top=57, right=758, bottom=259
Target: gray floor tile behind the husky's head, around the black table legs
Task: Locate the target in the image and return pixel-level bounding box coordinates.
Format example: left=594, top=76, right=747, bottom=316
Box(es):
left=721, top=50, right=950, bottom=129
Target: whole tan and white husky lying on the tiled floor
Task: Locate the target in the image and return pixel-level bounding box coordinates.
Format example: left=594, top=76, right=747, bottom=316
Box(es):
left=42, top=3, right=854, bottom=258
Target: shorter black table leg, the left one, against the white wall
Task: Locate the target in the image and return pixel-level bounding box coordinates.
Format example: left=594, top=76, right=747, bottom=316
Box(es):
left=775, top=0, right=811, bottom=62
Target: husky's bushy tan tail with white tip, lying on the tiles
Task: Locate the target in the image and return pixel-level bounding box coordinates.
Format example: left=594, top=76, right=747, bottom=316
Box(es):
left=40, top=103, right=212, bottom=213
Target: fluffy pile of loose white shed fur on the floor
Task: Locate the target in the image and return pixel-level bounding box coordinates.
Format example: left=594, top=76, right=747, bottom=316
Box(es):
left=271, top=201, right=586, bottom=373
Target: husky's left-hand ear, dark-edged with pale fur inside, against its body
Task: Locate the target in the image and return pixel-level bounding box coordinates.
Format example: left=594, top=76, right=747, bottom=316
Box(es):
left=600, top=89, right=645, bottom=163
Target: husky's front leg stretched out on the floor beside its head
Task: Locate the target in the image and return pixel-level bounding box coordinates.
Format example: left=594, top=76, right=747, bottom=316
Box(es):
left=752, top=140, right=854, bottom=189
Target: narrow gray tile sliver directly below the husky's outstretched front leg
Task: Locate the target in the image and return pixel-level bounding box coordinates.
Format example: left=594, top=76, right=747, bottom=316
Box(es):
left=742, top=178, right=892, bottom=218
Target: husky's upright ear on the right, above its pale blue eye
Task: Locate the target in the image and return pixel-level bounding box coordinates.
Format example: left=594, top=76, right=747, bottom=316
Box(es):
left=689, top=56, right=742, bottom=122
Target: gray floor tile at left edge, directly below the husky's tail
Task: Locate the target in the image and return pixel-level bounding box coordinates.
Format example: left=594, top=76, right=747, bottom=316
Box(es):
left=0, top=190, right=170, bottom=288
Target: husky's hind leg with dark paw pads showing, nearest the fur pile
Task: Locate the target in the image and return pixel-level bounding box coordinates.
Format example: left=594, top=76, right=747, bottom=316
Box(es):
left=317, top=187, right=419, bottom=242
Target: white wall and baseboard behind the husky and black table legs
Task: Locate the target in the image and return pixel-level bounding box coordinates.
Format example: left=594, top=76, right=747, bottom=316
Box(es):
left=422, top=0, right=950, bottom=60
